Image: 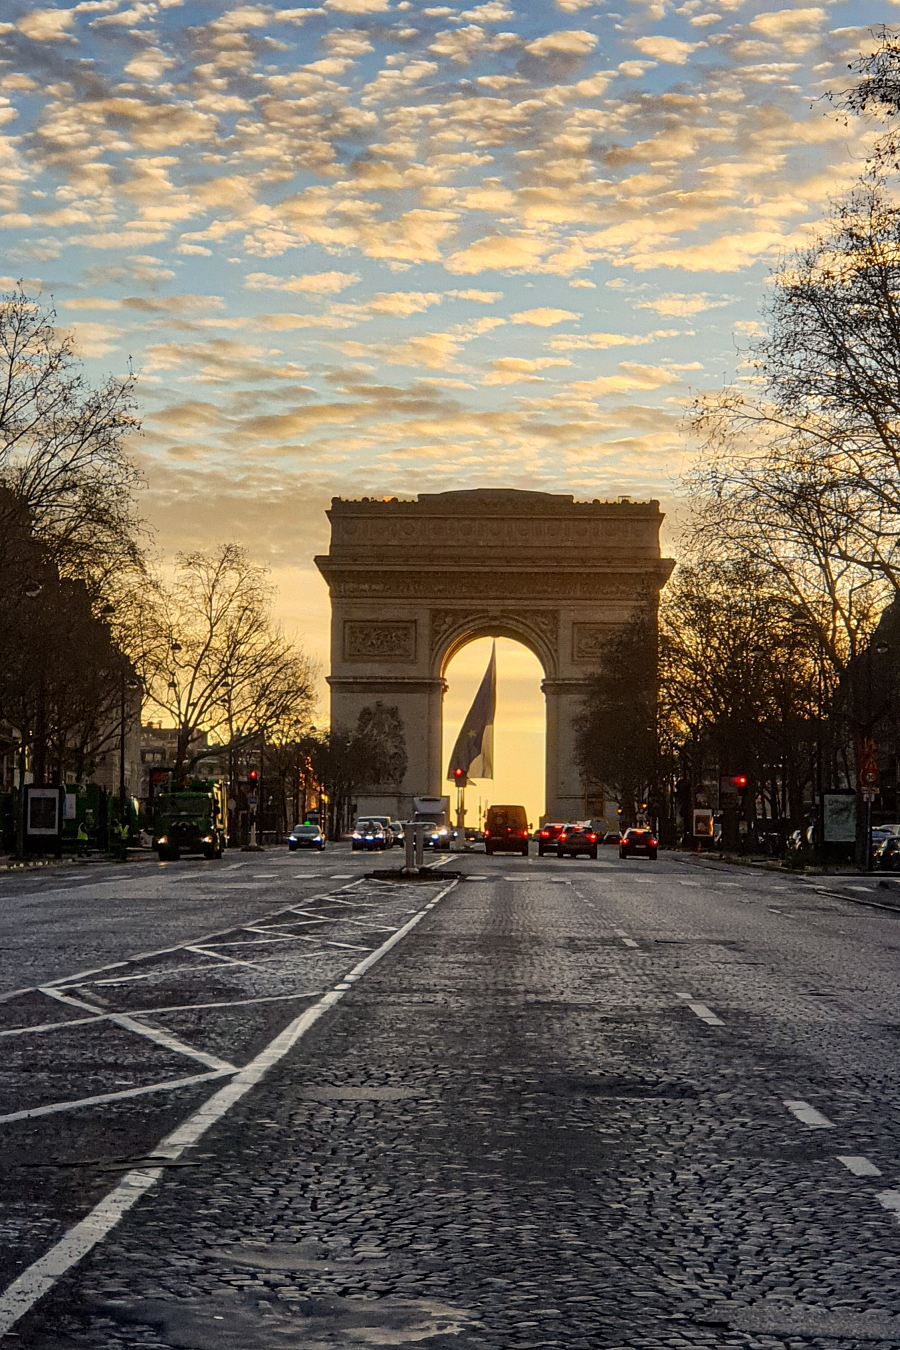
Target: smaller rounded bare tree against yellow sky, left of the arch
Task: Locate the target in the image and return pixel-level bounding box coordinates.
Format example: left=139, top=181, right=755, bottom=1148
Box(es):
left=133, top=544, right=314, bottom=776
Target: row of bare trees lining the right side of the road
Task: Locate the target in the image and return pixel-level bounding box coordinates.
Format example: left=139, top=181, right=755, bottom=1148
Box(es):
left=579, top=30, right=900, bottom=832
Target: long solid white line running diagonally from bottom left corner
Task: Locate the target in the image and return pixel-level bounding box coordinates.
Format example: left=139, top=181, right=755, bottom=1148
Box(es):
left=0, top=882, right=456, bottom=1335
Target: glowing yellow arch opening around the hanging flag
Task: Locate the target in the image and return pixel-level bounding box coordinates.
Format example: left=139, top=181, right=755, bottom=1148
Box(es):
left=441, top=636, right=546, bottom=828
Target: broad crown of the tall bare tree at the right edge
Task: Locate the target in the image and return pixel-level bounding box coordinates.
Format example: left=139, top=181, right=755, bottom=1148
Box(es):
left=688, top=184, right=900, bottom=670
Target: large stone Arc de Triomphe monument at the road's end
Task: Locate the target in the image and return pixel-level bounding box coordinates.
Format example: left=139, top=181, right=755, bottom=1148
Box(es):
left=316, top=489, right=673, bottom=821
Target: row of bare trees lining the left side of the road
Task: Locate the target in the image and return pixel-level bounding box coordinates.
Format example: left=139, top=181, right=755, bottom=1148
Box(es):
left=0, top=289, right=323, bottom=799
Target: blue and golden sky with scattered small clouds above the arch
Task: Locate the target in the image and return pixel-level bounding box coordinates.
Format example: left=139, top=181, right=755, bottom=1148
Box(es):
left=0, top=0, right=900, bottom=810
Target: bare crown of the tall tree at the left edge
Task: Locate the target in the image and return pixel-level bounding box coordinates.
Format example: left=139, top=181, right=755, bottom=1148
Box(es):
left=0, top=288, right=142, bottom=594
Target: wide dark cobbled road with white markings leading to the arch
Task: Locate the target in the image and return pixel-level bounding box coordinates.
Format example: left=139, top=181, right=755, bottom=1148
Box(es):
left=0, top=848, right=900, bottom=1350
